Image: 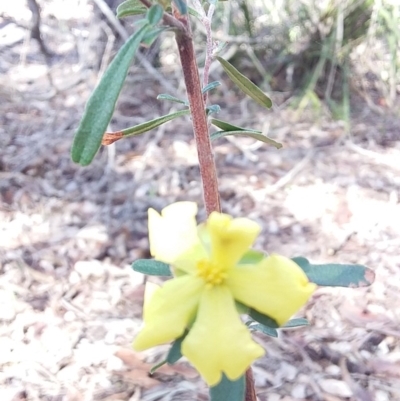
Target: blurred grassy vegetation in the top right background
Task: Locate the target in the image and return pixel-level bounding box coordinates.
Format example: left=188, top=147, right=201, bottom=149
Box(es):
left=202, top=0, right=400, bottom=122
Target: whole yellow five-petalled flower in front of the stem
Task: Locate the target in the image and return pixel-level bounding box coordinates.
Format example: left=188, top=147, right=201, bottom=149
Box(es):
left=134, top=202, right=315, bottom=386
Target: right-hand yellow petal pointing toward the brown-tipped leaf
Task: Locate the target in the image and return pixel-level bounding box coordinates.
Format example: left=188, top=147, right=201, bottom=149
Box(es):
left=225, top=254, right=316, bottom=326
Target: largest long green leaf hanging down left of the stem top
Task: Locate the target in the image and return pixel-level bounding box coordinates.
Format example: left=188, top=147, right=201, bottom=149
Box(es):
left=71, top=26, right=148, bottom=166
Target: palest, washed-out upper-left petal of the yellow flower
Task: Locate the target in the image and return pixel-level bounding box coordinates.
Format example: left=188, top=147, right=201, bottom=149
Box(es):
left=149, top=202, right=199, bottom=264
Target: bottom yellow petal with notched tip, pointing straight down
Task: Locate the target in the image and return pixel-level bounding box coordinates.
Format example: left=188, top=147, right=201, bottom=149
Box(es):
left=182, top=286, right=264, bottom=386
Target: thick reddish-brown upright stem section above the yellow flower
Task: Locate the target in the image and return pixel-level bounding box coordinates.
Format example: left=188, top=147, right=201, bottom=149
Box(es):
left=174, top=10, right=221, bottom=215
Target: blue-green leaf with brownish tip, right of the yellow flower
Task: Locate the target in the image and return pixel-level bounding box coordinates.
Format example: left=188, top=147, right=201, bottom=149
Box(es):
left=292, top=257, right=375, bottom=288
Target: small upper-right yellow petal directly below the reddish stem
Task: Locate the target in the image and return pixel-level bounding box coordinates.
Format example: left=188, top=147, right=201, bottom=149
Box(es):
left=207, top=212, right=261, bottom=268
